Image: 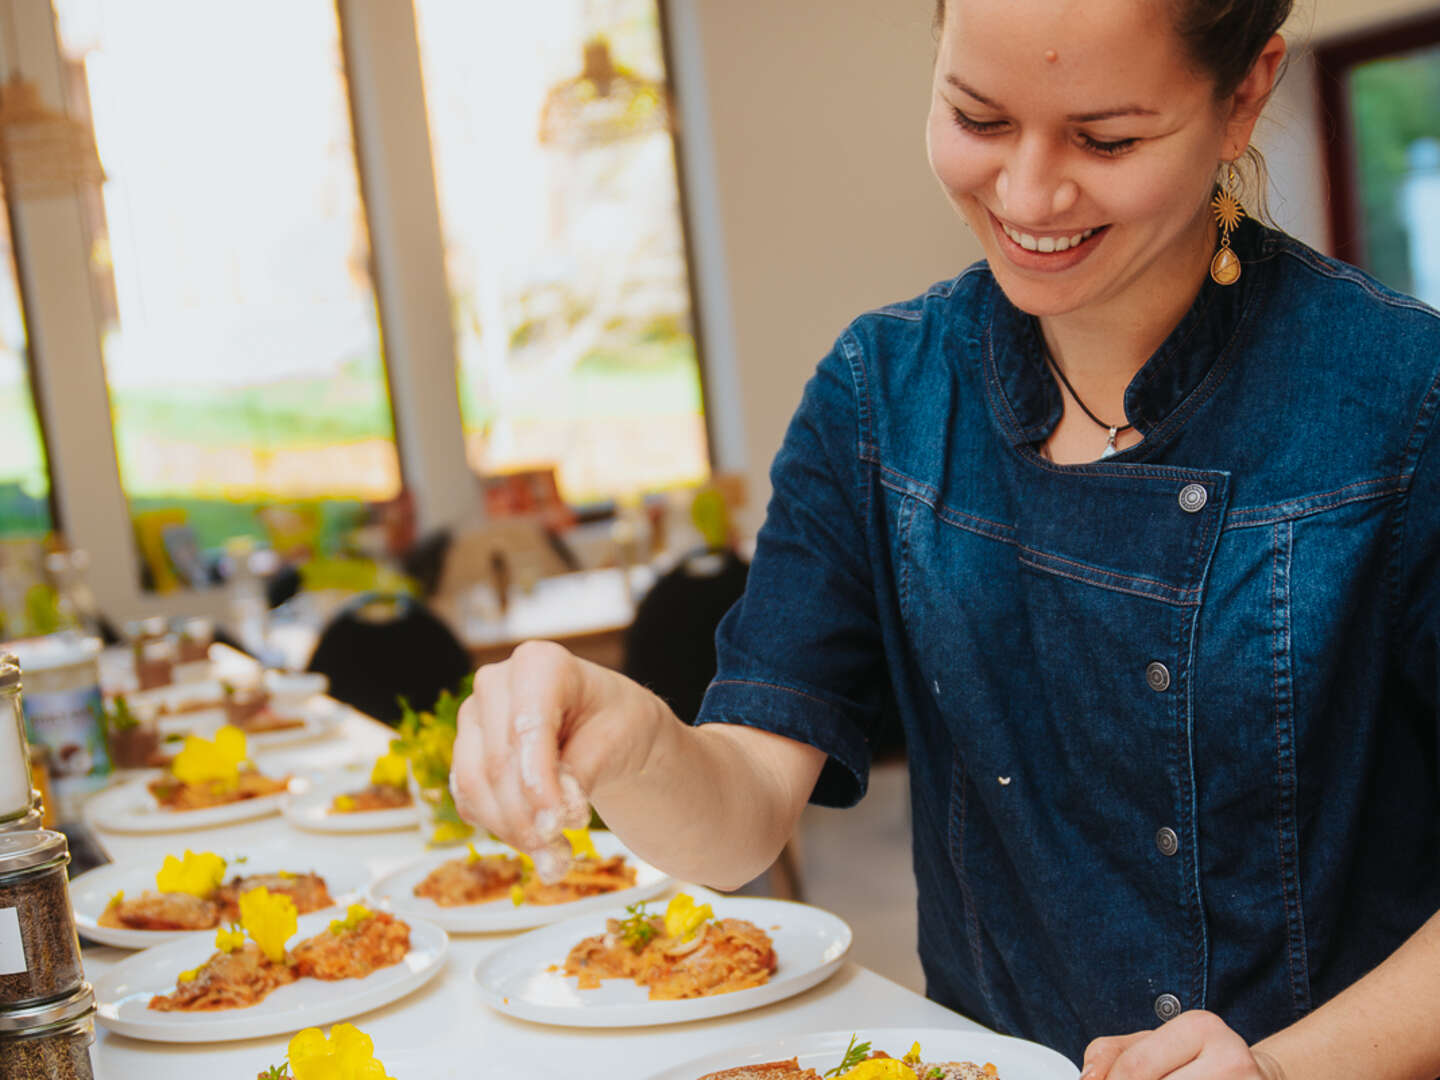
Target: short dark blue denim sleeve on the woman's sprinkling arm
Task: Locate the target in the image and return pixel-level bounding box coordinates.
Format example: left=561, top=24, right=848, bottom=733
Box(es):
left=697, top=337, right=888, bottom=806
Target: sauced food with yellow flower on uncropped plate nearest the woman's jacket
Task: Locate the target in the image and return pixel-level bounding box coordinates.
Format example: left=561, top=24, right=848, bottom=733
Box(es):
left=564, top=893, right=776, bottom=1001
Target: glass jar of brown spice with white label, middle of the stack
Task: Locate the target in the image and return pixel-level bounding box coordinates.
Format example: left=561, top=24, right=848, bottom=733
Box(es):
left=0, top=829, right=85, bottom=1012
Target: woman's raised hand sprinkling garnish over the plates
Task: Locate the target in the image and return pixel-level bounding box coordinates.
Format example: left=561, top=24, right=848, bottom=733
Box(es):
left=451, top=641, right=665, bottom=852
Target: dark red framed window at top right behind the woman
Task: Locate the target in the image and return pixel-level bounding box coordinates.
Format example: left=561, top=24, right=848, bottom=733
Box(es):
left=1316, top=16, right=1440, bottom=305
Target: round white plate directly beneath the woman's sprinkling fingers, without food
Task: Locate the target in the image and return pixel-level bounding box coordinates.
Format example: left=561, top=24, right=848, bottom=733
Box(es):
left=369, top=832, right=671, bottom=933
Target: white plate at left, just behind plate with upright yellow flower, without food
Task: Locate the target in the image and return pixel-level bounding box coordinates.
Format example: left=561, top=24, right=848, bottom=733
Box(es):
left=71, top=844, right=370, bottom=949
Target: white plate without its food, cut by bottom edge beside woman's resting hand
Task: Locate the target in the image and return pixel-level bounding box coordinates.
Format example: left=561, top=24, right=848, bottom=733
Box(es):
left=649, top=1028, right=1080, bottom=1080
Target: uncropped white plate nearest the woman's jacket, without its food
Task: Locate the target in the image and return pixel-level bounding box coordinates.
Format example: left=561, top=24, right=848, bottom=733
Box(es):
left=475, top=897, right=851, bottom=1028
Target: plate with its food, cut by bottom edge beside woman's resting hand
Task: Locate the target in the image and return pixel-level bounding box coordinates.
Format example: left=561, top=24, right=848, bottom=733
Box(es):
left=648, top=1028, right=1077, bottom=1080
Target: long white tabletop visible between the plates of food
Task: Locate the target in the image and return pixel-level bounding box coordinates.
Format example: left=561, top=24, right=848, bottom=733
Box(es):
left=75, top=711, right=984, bottom=1080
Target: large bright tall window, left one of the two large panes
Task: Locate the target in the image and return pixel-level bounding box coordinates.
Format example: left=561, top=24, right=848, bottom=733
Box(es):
left=55, top=0, right=400, bottom=567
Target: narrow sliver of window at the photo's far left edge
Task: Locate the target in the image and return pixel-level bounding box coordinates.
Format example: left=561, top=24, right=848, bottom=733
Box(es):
left=0, top=185, right=52, bottom=537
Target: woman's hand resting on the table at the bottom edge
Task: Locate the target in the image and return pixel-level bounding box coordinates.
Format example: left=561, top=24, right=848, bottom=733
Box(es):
left=1080, top=1009, right=1286, bottom=1080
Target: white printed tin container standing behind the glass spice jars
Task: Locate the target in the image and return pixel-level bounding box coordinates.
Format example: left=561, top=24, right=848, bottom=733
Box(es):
left=10, top=634, right=111, bottom=822
